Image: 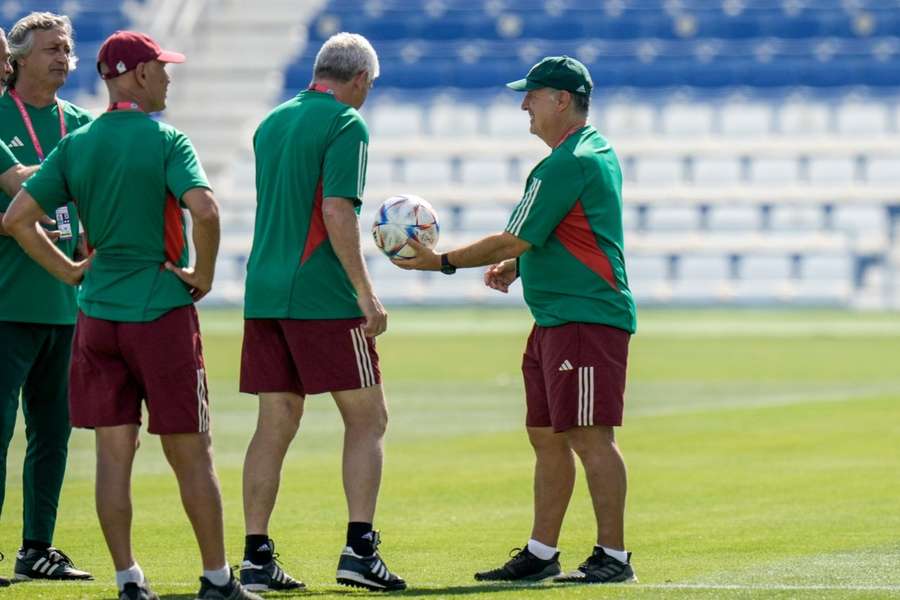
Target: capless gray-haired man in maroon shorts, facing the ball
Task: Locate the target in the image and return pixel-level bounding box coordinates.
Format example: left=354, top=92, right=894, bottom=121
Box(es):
left=241, top=33, right=406, bottom=591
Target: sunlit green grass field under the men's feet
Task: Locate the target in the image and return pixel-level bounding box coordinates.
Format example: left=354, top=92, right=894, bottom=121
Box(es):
left=0, top=310, right=900, bottom=600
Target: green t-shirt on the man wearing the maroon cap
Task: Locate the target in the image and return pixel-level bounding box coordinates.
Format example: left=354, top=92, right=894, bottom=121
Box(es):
left=24, top=110, right=209, bottom=322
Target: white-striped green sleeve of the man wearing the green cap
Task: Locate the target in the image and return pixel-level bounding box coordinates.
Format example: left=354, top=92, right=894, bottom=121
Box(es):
left=506, top=154, right=584, bottom=247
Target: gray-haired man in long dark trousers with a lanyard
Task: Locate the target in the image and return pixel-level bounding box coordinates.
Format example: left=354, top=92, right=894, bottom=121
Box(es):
left=0, top=13, right=91, bottom=580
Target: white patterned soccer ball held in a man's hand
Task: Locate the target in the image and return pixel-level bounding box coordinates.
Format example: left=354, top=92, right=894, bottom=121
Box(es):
left=372, top=194, right=440, bottom=258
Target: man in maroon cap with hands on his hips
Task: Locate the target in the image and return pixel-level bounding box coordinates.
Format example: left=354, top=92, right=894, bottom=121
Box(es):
left=3, top=31, right=259, bottom=600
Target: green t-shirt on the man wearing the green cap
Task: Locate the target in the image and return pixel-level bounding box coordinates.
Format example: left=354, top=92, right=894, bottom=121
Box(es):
left=506, top=126, right=637, bottom=333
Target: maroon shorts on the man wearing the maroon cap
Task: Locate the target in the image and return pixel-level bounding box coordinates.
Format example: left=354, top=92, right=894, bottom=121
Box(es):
left=69, top=304, right=209, bottom=435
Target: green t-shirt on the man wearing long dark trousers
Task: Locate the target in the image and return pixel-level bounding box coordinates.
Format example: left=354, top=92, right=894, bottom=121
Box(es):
left=0, top=94, right=92, bottom=325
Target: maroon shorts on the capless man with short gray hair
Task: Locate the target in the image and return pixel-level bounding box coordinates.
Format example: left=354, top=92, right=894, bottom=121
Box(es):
left=241, top=318, right=381, bottom=396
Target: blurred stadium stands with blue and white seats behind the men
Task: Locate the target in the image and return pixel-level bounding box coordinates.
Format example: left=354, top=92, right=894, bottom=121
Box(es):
left=19, top=0, right=900, bottom=310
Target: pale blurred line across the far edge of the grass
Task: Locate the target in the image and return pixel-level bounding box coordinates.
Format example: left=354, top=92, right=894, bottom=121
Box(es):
left=201, top=315, right=900, bottom=338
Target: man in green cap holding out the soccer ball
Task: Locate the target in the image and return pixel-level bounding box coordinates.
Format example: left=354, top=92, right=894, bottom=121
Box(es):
left=394, top=56, right=636, bottom=583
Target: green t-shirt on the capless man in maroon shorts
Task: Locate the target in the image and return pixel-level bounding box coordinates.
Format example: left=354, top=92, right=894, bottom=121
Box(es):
left=244, top=90, right=369, bottom=319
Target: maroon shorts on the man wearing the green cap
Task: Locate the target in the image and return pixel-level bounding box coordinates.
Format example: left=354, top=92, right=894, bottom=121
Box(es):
left=522, top=323, right=631, bottom=432
